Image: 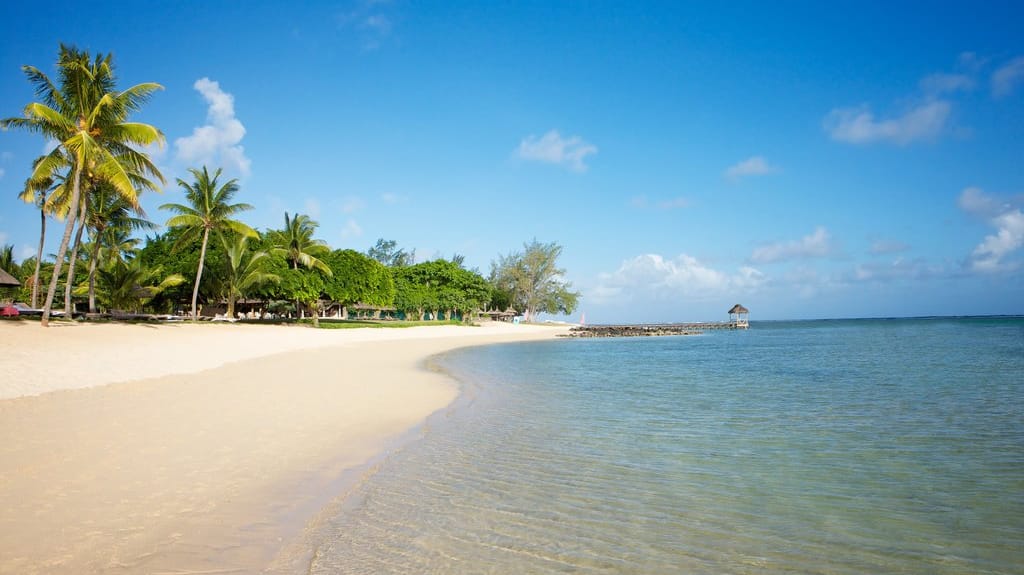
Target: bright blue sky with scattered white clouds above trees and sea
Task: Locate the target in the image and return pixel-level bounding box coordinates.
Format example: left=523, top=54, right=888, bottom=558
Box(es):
left=0, top=1, right=1024, bottom=322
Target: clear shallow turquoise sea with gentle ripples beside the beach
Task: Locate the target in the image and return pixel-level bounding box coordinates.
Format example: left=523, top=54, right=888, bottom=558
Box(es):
left=310, top=318, right=1024, bottom=574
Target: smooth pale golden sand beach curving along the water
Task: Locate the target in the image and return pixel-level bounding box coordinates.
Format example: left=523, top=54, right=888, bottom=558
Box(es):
left=0, top=321, right=563, bottom=574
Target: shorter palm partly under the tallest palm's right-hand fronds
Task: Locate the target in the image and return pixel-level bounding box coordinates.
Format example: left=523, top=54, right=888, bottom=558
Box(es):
left=79, top=182, right=157, bottom=313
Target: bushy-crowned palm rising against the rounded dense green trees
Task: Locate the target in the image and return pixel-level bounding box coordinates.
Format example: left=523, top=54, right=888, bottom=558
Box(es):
left=268, top=212, right=333, bottom=326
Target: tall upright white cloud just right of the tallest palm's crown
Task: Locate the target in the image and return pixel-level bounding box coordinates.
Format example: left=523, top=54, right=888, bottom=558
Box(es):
left=174, top=78, right=252, bottom=176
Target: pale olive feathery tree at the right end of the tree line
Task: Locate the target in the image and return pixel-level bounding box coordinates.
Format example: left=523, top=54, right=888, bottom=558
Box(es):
left=490, top=238, right=580, bottom=321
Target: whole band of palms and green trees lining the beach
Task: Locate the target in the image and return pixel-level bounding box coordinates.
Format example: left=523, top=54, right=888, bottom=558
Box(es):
left=0, top=46, right=579, bottom=325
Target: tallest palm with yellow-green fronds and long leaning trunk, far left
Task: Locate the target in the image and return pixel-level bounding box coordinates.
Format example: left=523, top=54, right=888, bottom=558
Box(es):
left=0, top=45, right=164, bottom=326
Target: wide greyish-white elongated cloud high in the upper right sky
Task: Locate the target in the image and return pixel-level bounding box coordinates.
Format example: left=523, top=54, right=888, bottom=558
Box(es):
left=824, top=100, right=951, bottom=144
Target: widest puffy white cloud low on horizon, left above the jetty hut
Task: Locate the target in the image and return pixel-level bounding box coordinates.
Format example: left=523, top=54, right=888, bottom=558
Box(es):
left=587, top=254, right=765, bottom=304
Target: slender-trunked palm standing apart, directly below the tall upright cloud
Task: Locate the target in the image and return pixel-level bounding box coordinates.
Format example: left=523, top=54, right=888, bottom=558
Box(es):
left=160, top=166, right=258, bottom=319
